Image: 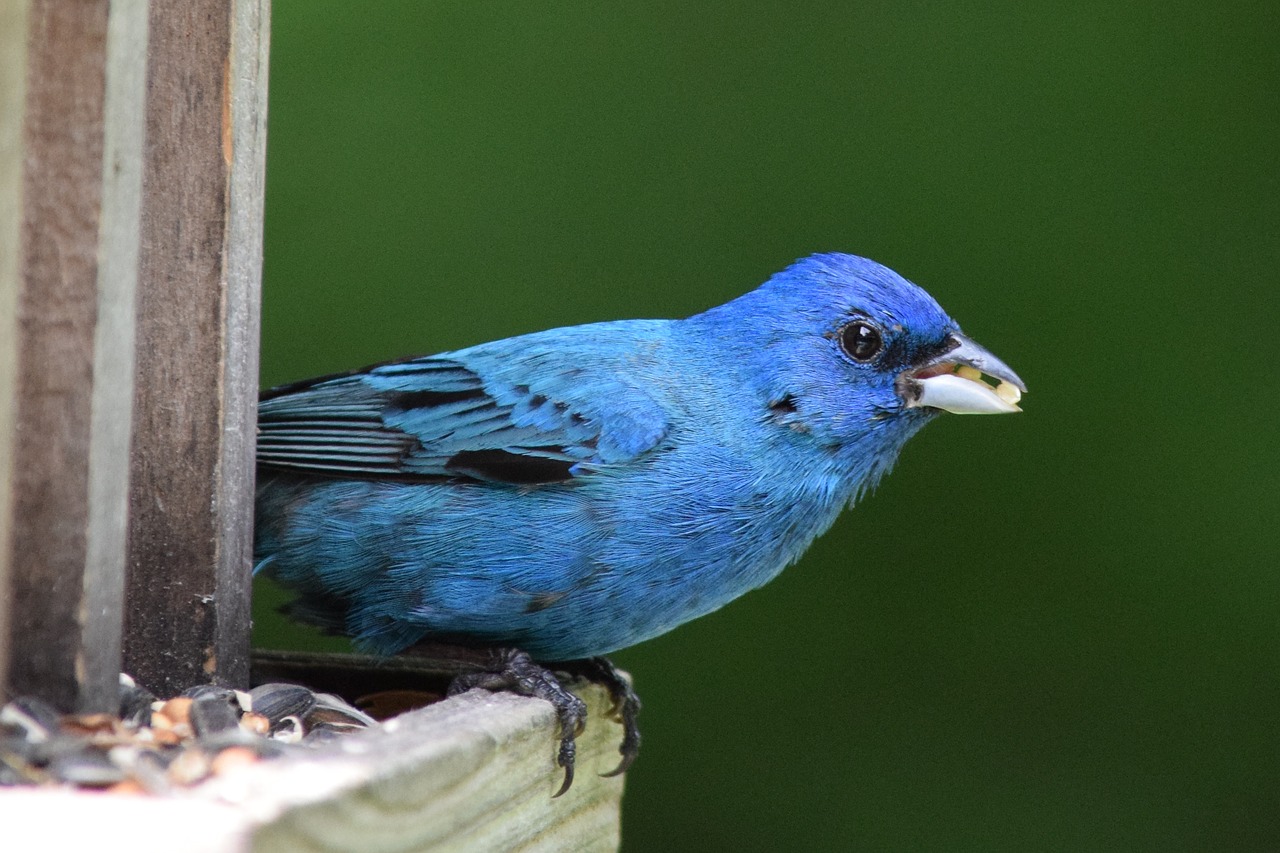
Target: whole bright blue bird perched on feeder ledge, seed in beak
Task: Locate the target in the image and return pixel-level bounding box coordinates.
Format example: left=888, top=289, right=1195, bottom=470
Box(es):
left=256, top=254, right=1025, bottom=793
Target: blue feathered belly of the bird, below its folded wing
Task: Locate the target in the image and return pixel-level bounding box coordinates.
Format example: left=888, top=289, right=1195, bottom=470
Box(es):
left=257, top=448, right=842, bottom=660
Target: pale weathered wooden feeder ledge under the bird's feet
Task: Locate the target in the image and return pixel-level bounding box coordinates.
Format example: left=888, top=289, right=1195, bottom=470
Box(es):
left=0, top=685, right=623, bottom=853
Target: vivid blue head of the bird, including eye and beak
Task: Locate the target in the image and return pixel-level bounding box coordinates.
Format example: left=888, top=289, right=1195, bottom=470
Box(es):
left=695, top=254, right=1027, bottom=455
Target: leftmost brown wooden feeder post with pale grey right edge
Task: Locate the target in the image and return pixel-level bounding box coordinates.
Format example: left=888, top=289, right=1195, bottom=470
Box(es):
left=0, top=0, right=146, bottom=710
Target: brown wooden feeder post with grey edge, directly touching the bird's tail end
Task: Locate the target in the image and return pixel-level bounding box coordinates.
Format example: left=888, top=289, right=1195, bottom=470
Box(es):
left=124, top=0, right=269, bottom=695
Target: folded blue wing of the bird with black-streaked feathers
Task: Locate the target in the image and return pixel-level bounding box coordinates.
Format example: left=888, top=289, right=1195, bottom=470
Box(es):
left=257, top=330, right=668, bottom=485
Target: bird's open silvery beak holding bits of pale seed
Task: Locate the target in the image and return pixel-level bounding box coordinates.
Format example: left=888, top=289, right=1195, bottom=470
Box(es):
left=897, top=332, right=1027, bottom=415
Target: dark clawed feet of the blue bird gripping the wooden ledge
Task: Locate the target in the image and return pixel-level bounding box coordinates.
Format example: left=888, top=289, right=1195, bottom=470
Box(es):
left=449, top=648, right=640, bottom=797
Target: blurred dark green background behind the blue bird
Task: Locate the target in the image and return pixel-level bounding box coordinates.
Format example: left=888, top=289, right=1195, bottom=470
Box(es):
left=256, top=0, right=1280, bottom=852
